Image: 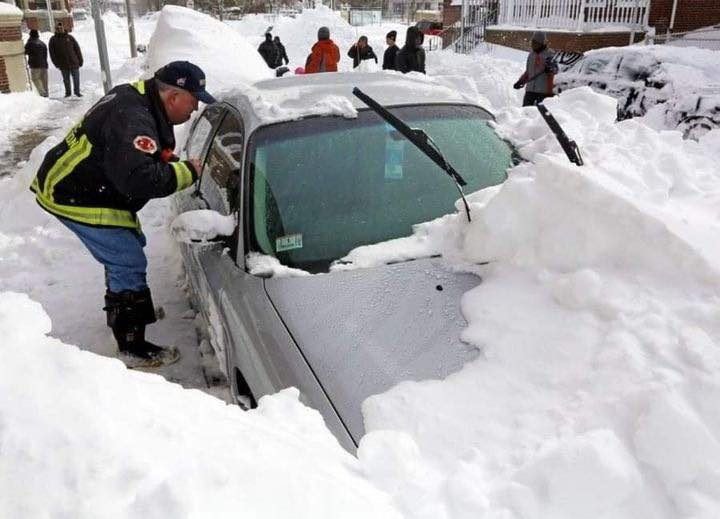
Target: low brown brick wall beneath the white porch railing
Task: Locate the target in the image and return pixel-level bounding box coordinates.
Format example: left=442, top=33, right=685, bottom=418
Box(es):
left=485, top=27, right=645, bottom=52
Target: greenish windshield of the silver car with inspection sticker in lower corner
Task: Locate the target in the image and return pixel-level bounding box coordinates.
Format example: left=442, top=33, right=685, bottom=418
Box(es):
left=249, top=105, right=513, bottom=272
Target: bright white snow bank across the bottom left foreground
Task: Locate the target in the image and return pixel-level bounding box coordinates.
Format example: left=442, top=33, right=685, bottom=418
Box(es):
left=0, top=292, right=400, bottom=519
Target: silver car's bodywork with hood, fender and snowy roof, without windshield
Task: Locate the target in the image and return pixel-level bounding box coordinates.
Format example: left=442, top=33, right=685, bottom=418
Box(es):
left=178, top=73, right=500, bottom=451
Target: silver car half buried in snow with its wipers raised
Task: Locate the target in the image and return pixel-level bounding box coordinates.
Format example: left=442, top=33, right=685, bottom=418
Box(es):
left=178, top=73, right=514, bottom=450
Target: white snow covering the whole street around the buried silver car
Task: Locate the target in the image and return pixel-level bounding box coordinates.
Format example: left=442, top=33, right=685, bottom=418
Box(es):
left=0, top=8, right=720, bottom=519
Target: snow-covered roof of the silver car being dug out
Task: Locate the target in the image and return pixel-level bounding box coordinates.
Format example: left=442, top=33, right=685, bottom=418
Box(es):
left=218, top=72, right=484, bottom=134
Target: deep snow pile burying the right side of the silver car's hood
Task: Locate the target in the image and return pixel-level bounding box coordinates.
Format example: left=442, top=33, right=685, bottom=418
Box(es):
left=359, top=88, right=720, bottom=519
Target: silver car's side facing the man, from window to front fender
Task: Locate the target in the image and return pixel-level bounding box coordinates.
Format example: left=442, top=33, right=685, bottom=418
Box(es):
left=186, top=110, right=355, bottom=450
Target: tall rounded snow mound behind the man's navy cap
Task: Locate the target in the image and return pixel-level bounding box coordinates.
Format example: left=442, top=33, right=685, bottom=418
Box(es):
left=147, top=5, right=274, bottom=94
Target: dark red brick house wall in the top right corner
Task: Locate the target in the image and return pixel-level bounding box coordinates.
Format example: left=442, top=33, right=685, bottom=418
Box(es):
left=648, top=0, right=720, bottom=34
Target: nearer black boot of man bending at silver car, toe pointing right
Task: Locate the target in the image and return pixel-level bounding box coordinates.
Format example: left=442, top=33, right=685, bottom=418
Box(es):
left=104, top=289, right=180, bottom=367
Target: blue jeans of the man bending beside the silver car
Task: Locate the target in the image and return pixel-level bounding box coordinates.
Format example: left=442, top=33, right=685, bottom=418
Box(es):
left=58, top=218, right=147, bottom=293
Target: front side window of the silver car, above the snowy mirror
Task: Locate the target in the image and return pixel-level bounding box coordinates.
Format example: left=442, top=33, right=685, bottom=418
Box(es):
left=200, top=112, right=244, bottom=215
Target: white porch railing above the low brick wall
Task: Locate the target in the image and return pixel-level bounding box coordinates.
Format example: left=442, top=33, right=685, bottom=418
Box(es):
left=498, top=0, right=650, bottom=31
